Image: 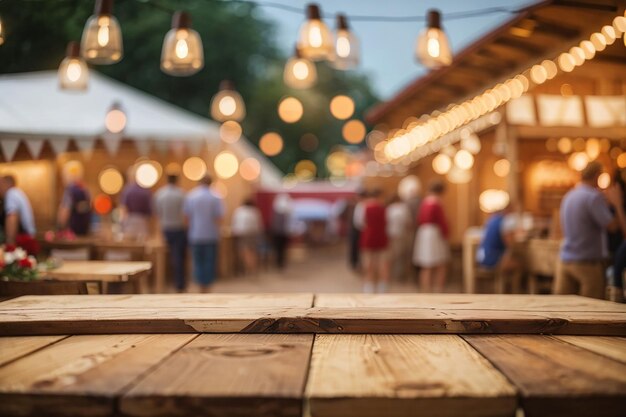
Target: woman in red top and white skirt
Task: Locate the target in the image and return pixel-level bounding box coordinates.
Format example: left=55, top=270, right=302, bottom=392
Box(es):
left=413, top=180, right=450, bottom=292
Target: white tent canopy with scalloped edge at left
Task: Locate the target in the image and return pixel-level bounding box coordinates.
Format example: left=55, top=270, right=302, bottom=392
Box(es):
left=0, top=70, right=282, bottom=187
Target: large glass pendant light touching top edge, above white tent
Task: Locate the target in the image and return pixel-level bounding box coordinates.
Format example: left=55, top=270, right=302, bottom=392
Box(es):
left=81, top=0, right=122, bottom=65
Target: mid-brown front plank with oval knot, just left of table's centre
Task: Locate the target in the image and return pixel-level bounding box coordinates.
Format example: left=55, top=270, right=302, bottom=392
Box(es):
left=120, top=334, right=313, bottom=417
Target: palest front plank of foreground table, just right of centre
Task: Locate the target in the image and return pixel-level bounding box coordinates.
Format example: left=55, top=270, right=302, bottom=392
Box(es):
left=306, top=335, right=517, bottom=417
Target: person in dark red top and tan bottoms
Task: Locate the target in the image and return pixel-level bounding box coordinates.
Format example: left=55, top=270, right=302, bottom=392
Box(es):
left=355, top=190, right=389, bottom=294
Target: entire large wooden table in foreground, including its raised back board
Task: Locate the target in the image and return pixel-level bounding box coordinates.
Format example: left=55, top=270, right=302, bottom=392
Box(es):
left=0, top=294, right=626, bottom=417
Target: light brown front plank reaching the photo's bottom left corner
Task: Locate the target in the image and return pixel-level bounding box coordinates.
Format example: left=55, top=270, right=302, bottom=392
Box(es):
left=0, top=335, right=196, bottom=416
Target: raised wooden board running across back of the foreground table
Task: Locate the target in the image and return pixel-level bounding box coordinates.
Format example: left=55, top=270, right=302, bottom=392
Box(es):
left=0, top=294, right=626, bottom=336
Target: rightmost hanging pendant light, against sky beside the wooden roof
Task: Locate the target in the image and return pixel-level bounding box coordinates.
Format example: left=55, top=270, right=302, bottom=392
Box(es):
left=416, top=10, right=452, bottom=68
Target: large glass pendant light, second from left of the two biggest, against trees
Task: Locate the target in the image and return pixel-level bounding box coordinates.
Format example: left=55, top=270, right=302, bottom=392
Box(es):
left=161, top=12, right=204, bottom=77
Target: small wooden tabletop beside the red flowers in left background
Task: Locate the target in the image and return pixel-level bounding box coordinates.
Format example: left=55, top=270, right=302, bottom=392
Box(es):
left=44, top=261, right=152, bottom=281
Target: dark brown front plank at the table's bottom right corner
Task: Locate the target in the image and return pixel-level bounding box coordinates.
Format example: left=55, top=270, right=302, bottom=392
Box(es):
left=463, top=335, right=626, bottom=417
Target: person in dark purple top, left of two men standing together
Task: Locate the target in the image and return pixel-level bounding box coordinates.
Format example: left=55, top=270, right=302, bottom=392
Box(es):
left=120, top=168, right=152, bottom=240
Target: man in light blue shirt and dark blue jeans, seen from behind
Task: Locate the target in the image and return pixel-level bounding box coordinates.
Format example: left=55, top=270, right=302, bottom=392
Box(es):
left=183, top=175, right=224, bottom=292
